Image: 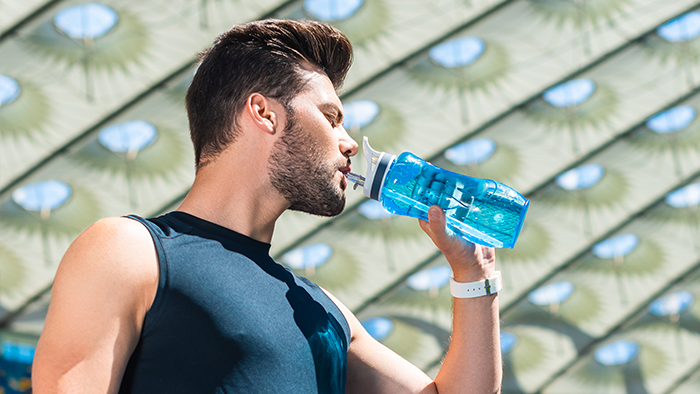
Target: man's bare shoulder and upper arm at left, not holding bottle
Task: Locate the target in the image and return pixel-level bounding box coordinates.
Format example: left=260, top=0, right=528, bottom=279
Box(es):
left=32, top=218, right=158, bottom=394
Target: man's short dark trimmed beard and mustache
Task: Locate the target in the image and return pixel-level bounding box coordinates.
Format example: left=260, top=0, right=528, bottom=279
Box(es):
left=269, top=111, right=350, bottom=216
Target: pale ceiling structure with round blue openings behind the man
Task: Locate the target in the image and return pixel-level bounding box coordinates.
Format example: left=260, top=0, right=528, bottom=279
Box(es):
left=0, top=0, right=700, bottom=393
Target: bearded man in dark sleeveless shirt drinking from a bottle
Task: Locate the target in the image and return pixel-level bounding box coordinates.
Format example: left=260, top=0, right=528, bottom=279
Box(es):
left=33, top=20, right=501, bottom=394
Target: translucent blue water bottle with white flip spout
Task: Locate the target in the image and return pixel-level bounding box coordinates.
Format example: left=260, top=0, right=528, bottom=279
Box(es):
left=347, top=137, right=530, bottom=248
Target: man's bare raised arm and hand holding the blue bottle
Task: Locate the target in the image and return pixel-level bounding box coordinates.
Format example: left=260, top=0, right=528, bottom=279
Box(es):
left=342, top=207, right=502, bottom=394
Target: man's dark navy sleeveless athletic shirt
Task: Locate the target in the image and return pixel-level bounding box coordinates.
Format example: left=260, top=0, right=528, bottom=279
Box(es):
left=119, top=212, right=350, bottom=394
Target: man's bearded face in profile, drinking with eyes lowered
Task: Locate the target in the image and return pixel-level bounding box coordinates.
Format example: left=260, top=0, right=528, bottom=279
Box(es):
left=269, top=72, right=357, bottom=216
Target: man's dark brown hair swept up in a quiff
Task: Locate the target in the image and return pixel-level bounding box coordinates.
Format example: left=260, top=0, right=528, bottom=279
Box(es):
left=185, top=19, right=352, bottom=168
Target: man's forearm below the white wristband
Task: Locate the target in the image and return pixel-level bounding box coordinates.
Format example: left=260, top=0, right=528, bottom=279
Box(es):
left=435, top=294, right=503, bottom=394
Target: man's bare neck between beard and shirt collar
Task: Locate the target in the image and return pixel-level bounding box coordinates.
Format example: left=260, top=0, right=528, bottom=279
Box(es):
left=177, top=143, right=289, bottom=243
